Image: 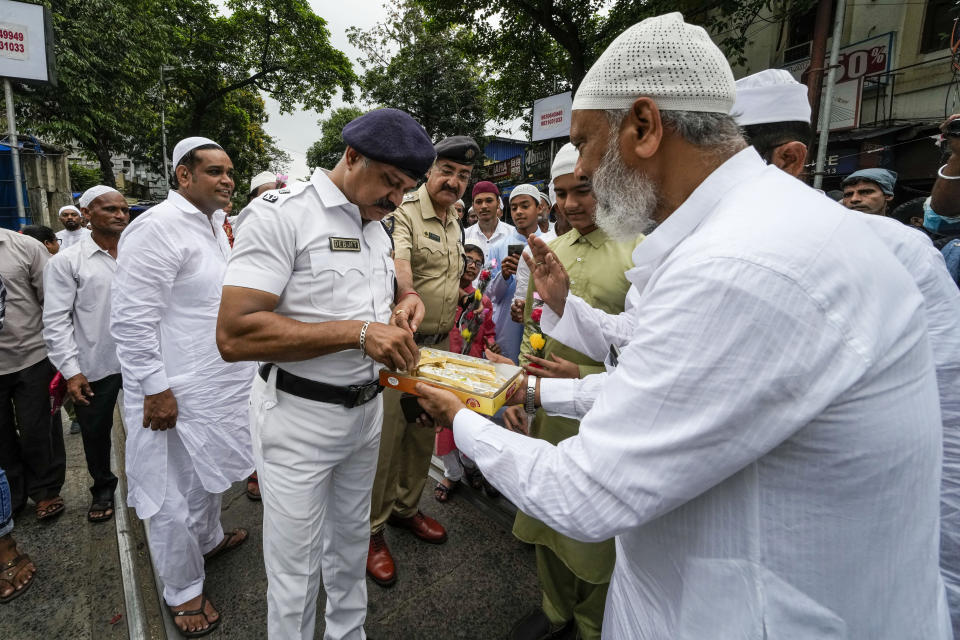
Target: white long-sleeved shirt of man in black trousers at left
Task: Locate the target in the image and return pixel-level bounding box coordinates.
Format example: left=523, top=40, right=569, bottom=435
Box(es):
left=43, top=234, right=120, bottom=382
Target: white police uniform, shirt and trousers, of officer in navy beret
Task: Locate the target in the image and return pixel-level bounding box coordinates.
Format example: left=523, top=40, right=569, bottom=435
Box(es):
left=224, top=170, right=395, bottom=639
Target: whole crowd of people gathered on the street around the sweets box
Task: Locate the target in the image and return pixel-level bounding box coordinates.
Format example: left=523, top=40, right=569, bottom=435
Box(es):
left=0, top=8, right=960, bottom=640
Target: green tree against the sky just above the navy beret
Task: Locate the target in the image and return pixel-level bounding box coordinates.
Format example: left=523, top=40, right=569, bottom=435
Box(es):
left=347, top=2, right=489, bottom=140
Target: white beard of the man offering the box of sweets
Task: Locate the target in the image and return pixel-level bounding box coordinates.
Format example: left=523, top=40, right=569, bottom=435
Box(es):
left=591, top=137, right=660, bottom=240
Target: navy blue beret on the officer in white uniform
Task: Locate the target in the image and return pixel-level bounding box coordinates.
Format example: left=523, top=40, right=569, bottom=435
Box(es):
left=342, top=108, right=436, bottom=180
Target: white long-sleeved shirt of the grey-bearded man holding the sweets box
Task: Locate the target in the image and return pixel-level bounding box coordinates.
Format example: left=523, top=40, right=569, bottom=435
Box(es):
left=454, top=149, right=950, bottom=640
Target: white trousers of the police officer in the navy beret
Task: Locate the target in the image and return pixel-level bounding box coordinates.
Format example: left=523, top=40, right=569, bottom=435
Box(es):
left=250, top=368, right=383, bottom=640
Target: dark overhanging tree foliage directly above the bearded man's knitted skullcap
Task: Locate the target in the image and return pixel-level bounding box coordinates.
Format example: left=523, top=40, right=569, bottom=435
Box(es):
left=414, top=0, right=813, bottom=124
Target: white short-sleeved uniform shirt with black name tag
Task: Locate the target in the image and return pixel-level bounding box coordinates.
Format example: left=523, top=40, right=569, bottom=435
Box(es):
left=223, top=169, right=396, bottom=386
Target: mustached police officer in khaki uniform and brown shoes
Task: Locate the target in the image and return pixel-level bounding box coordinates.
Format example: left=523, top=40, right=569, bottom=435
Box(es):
left=367, top=136, right=480, bottom=587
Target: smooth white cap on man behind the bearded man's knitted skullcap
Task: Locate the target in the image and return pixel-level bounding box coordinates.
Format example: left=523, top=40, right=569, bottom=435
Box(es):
left=730, top=69, right=811, bottom=127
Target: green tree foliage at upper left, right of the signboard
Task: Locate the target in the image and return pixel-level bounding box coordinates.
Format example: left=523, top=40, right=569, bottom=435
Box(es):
left=17, top=0, right=356, bottom=188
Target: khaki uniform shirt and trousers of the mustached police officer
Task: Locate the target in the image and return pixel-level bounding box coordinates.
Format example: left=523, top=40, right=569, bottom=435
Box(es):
left=370, top=185, right=463, bottom=533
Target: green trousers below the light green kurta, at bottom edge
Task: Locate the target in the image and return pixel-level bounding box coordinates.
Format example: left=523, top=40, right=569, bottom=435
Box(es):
left=536, top=544, right=610, bottom=640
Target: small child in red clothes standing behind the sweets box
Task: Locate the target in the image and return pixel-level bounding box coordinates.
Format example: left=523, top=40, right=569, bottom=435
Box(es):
left=433, top=244, right=500, bottom=502
